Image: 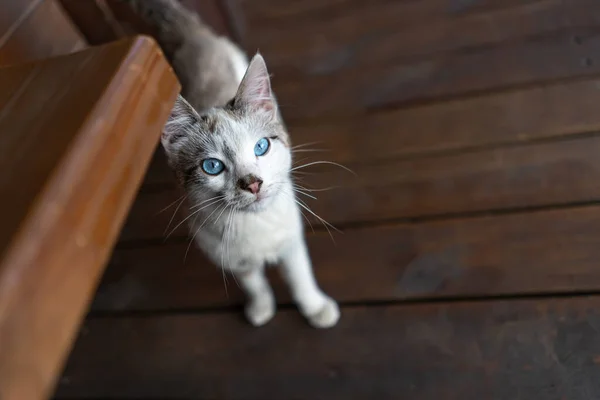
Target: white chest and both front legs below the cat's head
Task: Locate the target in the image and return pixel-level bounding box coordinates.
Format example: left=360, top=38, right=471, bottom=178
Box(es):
left=192, top=183, right=339, bottom=328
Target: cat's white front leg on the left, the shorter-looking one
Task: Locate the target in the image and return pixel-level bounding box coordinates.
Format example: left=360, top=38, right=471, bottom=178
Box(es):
left=233, top=266, right=276, bottom=326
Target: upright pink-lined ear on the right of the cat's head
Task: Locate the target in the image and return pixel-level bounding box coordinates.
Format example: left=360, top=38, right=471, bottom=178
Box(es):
left=235, top=53, right=277, bottom=117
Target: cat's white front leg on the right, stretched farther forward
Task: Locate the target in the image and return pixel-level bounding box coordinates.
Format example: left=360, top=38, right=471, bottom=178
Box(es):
left=280, top=237, right=340, bottom=328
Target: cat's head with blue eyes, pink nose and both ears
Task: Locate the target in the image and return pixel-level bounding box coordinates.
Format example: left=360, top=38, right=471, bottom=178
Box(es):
left=161, top=54, right=292, bottom=212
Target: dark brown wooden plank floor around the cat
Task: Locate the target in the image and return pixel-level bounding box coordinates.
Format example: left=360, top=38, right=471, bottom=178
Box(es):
left=57, top=0, right=600, bottom=400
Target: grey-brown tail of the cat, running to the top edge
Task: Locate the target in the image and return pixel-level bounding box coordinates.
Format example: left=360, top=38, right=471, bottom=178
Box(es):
left=121, top=0, right=215, bottom=58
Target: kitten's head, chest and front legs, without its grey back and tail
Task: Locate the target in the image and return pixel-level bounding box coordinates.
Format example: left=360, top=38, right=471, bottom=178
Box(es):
left=162, top=55, right=340, bottom=328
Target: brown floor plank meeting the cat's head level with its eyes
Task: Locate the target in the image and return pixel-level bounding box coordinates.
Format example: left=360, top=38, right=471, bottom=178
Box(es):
left=142, top=77, right=600, bottom=192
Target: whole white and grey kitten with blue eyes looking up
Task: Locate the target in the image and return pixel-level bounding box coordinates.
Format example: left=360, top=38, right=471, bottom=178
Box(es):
left=124, top=0, right=340, bottom=328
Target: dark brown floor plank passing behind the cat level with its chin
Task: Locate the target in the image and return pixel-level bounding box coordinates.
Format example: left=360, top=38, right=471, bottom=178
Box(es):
left=121, top=135, right=600, bottom=241
